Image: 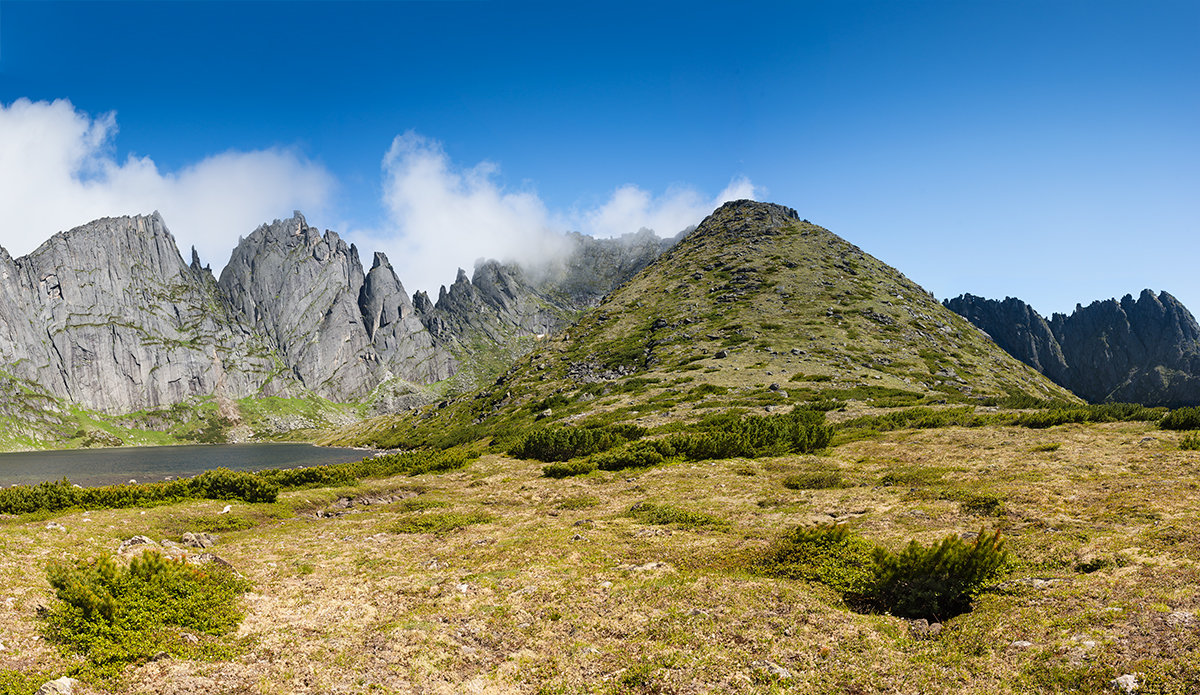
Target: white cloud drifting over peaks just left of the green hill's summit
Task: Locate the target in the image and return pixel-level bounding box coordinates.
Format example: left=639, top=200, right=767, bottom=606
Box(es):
left=364, top=132, right=761, bottom=294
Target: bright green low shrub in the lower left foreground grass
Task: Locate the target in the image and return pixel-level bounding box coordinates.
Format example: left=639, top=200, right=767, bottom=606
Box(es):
left=43, top=552, right=250, bottom=678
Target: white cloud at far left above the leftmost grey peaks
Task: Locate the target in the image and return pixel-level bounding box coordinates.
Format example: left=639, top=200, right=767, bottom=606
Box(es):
left=0, top=98, right=334, bottom=271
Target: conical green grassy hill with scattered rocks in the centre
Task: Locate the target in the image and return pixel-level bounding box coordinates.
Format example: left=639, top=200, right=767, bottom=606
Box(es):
left=325, top=200, right=1078, bottom=447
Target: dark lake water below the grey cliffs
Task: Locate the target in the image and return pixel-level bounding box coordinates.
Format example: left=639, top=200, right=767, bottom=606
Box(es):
left=0, top=444, right=371, bottom=486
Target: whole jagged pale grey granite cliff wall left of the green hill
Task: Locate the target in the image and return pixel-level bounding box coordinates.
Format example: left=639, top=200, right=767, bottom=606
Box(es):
left=0, top=212, right=662, bottom=413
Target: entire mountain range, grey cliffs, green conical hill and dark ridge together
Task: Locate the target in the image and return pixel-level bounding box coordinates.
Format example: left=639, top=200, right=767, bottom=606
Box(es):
left=0, top=200, right=1200, bottom=447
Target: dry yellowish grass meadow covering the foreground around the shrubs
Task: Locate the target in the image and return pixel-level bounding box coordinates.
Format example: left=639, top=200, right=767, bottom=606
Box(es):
left=0, top=423, right=1200, bottom=695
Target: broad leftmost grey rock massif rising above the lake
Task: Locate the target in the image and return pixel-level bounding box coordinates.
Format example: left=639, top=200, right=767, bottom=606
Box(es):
left=0, top=212, right=296, bottom=413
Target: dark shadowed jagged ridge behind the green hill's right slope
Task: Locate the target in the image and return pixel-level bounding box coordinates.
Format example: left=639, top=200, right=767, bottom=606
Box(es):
left=944, top=289, right=1200, bottom=407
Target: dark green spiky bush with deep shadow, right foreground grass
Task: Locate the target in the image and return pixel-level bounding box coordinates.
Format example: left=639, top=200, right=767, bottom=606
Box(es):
left=864, top=531, right=1008, bottom=621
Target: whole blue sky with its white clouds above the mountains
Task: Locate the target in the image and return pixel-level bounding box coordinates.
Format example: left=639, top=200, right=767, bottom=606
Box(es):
left=0, top=0, right=1200, bottom=313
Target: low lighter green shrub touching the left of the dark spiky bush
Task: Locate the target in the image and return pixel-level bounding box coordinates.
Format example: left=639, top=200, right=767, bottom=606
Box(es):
left=755, top=525, right=875, bottom=594
